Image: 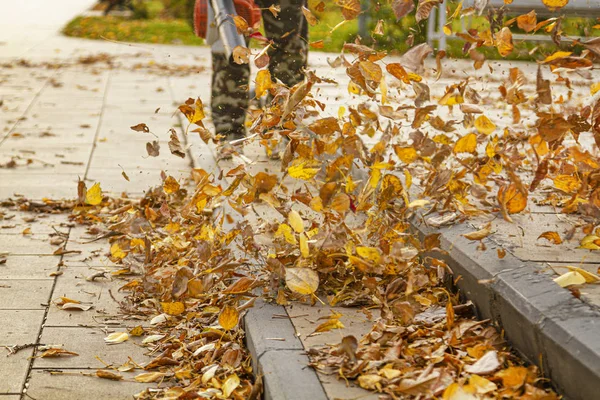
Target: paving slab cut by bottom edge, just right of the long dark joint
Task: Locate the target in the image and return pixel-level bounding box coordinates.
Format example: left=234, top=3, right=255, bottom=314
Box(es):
left=26, top=370, right=152, bottom=400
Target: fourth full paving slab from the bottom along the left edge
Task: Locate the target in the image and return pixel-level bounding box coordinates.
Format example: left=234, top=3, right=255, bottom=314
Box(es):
left=0, top=256, right=60, bottom=278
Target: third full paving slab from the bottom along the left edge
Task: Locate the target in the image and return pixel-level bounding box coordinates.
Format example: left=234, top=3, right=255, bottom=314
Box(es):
left=0, top=279, right=54, bottom=310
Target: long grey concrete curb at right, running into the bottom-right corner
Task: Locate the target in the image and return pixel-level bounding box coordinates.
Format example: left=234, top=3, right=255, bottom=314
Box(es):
left=411, top=217, right=600, bottom=400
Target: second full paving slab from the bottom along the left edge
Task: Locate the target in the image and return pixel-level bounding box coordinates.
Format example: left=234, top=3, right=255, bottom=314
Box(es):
left=0, top=310, right=44, bottom=344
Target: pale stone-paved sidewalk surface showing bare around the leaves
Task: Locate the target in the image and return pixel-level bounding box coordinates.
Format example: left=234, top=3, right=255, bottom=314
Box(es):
left=0, top=1, right=600, bottom=400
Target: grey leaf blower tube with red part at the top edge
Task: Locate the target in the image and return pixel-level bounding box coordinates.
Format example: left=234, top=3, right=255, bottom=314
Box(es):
left=194, top=0, right=260, bottom=60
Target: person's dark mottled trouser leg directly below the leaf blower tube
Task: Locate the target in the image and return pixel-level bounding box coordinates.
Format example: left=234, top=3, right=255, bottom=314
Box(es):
left=210, top=52, right=250, bottom=140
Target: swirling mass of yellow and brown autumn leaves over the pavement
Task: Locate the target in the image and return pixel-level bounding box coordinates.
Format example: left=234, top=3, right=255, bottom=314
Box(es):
left=1, top=0, right=600, bottom=400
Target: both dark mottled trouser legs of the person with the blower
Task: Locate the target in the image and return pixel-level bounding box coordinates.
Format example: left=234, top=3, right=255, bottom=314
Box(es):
left=211, top=0, right=308, bottom=139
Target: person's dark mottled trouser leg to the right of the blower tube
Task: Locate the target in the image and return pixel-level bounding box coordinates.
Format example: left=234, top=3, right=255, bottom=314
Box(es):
left=256, top=0, right=308, bottom=87
